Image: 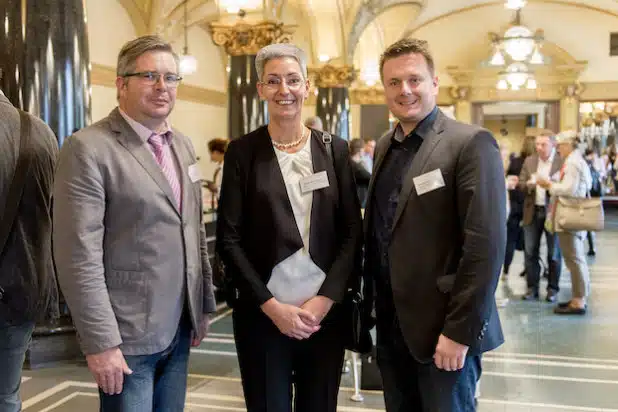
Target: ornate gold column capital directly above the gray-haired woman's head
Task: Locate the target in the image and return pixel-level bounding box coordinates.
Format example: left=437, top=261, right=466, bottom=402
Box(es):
left=209, top=21, right=296, bottom=56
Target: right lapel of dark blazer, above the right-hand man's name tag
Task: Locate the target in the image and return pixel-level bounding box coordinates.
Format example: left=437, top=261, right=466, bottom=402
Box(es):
left=391, top=111, right=444, bottom=231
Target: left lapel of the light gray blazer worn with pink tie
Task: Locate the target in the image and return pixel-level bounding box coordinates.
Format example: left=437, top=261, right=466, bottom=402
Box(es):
left=109, top=108, right=180, bottom=216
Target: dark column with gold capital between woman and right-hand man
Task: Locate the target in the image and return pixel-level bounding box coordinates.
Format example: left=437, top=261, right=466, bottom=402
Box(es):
left=311, top=65, right=354, bottom=140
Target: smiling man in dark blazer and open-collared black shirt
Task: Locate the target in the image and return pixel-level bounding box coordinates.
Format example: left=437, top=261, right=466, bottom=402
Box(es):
left=365, top=39, right=506, bottom=412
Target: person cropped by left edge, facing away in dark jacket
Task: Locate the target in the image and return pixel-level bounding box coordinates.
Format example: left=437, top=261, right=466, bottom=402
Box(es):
left=0, top=84, right=58, bottom=412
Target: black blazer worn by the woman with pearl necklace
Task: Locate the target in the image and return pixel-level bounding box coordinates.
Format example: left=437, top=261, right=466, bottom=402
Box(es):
left=217, top=126, right=362, bottom=305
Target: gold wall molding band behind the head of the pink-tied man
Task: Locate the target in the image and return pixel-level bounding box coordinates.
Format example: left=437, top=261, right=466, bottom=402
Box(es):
left=90, top=63, right=227, bottom=107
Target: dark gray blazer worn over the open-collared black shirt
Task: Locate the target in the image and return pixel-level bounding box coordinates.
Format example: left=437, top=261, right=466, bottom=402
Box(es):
left=365, top=111, right=506, bottom=362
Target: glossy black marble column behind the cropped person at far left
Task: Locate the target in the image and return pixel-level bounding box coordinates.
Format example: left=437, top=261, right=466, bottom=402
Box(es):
left=0, top=0, right=90, bottom=144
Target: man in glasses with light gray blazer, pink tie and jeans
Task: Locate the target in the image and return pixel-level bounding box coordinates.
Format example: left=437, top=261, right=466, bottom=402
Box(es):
left=54, top=36, right=215, bottom=412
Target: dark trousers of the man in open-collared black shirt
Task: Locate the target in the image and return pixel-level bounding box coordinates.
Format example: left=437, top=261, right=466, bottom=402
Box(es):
left=377, top=314, right=482, bottom=412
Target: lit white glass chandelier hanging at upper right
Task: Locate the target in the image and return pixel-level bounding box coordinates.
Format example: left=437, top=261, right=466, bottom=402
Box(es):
left=489, top=0, right=545, bottom=90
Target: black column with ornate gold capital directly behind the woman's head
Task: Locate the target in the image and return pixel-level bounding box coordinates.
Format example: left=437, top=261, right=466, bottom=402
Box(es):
left=210, top=20, right=292, bottom=139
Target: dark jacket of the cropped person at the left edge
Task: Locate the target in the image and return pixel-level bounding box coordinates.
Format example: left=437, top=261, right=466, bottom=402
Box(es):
left=0, top=93, right=58, bottom=325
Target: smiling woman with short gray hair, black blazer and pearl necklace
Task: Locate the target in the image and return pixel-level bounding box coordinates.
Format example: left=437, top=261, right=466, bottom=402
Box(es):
left=217, top=44, right=362, bottom=412
